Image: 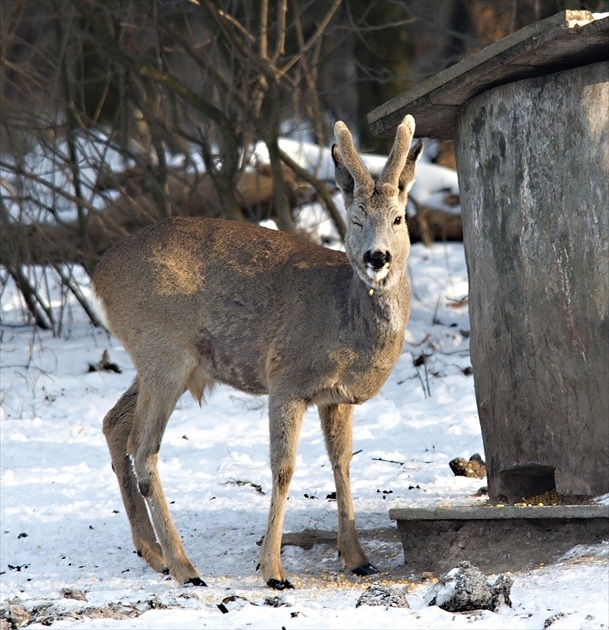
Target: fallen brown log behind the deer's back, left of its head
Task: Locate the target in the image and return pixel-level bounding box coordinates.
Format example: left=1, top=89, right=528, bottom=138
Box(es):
left=0, top=169, right=311, bottom=269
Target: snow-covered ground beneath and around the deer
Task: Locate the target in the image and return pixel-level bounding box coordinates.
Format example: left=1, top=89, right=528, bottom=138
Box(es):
left=0, top=244, right=609, bottom=630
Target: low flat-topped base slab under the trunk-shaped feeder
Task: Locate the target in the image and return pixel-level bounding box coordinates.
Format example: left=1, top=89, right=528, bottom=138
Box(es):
left=389, top=505, right=609, bottom=574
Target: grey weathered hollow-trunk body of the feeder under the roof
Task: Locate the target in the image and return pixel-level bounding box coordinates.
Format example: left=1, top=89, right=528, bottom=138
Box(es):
left=456, top=62, right=609, bottom=500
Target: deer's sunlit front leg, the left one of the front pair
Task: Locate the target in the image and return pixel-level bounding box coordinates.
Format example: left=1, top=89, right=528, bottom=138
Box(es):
left=259, top=392, right=307, bottom=590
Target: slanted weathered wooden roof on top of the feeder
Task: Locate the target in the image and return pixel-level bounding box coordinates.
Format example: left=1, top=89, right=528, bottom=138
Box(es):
left=368, top=11, right=609, bottom=138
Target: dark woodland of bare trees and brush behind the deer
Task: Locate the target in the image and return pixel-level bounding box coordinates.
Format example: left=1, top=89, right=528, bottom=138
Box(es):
left=0, top=0, right=609, bottom=334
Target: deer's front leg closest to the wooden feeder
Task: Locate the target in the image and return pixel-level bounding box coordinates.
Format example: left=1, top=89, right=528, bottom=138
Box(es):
left=319, top=404, right=378, bottom=575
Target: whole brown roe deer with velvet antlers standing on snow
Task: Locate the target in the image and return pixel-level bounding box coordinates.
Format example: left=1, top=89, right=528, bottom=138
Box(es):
left=94, top=116, right=422, bottom=590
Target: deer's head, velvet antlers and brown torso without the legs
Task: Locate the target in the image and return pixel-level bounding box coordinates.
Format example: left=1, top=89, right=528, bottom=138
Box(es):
left=94, top=115, right=420, bottom=402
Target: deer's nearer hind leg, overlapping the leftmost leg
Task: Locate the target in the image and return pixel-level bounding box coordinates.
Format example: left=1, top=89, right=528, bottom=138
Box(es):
left=127, top=369, right=205, bottom=586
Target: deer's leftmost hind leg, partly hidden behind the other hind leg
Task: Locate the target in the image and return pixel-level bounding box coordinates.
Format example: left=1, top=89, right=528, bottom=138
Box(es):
left=104, top=380, right=166, bottom=571
